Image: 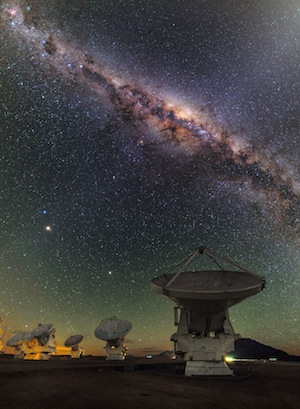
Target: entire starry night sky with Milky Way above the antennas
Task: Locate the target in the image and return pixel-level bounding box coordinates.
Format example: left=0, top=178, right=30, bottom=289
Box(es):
left=0, top=0, right=300, bottom=354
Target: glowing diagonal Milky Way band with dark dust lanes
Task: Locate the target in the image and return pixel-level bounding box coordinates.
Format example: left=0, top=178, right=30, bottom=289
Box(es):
left=2, top=3, right=300, bottom=224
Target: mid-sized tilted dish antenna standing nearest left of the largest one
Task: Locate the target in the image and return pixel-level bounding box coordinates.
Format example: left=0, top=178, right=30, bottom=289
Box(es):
left=95, top=317, right=132, bottom=360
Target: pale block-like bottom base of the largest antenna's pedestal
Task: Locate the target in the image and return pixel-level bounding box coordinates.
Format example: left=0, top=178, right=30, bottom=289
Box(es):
left=185, top=361, right=233, bottom=376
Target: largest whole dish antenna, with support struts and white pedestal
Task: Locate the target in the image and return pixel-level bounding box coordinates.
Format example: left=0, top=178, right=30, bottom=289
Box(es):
left=151, top=247, right=265, bottom=376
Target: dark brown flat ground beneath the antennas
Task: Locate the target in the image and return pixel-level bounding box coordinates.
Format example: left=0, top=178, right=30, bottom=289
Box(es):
left=0, top=358, right=300, bottom=409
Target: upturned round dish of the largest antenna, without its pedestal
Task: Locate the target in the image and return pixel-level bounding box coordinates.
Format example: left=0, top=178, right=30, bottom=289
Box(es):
left=151, top=270, right=265, bottom=313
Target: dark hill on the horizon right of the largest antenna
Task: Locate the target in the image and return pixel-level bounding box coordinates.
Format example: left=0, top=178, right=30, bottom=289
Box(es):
left=234, top=338, right=300, bottom=362
